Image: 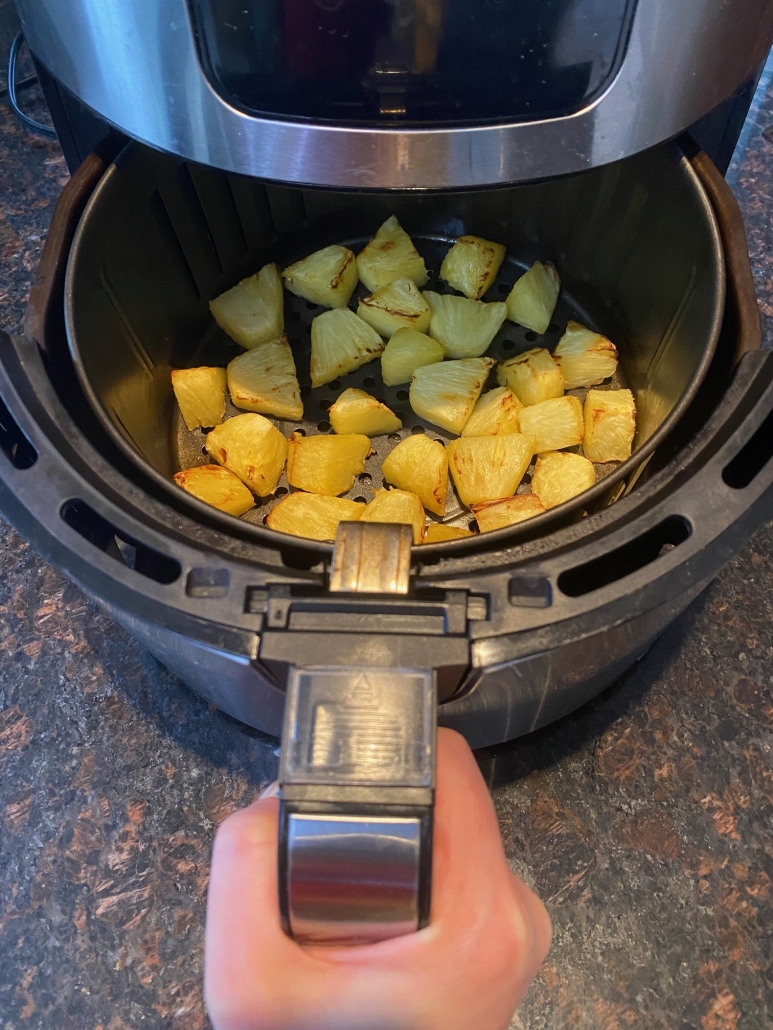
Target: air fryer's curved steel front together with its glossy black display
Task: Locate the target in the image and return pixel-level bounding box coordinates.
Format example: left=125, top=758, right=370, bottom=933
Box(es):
left=18, top=0, right=773, bottom=190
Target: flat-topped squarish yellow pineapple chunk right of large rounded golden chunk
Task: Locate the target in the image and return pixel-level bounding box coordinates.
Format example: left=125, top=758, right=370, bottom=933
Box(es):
left=288, top=433, right=370, bottom=497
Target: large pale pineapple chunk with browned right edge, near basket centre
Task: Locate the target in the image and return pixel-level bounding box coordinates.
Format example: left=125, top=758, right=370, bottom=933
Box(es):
left=410, top=357, right=496, bottom=434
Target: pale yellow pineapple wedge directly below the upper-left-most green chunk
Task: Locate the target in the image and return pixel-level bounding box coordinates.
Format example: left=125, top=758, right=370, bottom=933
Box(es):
left=227, top=336, right=303, bottom=418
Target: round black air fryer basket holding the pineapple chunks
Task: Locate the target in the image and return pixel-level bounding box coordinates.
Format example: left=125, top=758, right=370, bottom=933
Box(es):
left=66, top=144, right=725, bottom=551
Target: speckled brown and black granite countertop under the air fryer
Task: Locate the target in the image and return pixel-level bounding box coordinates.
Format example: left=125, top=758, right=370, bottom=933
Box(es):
left=0, top=54, right=773, bottom=1030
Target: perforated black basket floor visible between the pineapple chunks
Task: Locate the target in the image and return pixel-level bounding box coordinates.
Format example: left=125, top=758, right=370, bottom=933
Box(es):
left=172, top=236, right=627, bottom=530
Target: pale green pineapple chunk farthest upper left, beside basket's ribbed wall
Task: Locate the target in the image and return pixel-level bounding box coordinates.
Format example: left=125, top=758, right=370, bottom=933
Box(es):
left=209, top=265, right=284, bottom=350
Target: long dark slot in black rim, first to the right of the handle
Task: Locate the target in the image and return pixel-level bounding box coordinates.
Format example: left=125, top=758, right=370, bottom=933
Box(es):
left=559, top=515, right=692, bottom=597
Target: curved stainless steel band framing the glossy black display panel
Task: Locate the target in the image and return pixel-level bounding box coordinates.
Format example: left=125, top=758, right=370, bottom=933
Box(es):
left=16, top=0, right=773, bottom=190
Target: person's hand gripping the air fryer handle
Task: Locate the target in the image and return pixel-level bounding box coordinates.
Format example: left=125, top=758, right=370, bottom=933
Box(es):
left=204, top=729, right=550, bottom=1030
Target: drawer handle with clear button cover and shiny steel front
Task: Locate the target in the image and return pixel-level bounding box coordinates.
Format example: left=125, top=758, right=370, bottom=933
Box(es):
left=279, top=667, right=436, bottom=945
